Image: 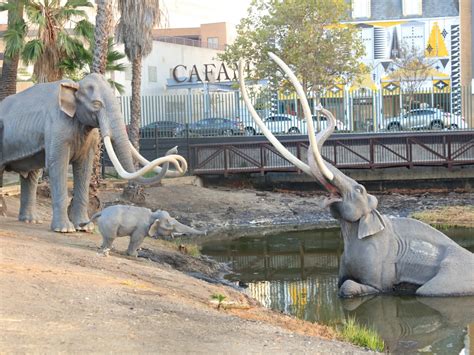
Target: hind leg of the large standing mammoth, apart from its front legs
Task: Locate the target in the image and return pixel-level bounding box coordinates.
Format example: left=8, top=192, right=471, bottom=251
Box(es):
left=18, top=170, right=42, bottom=223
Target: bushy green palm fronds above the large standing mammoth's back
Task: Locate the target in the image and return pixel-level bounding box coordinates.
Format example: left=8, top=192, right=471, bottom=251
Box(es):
left=0, top=0, right=125, bottom=92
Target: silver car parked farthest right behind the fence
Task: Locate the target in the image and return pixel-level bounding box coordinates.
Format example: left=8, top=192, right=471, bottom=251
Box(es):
left=379, top=108, right=467, bottom=131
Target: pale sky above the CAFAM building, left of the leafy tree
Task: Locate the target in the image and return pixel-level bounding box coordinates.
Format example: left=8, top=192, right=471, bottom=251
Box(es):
left=0, top=0, right=251, bottom=27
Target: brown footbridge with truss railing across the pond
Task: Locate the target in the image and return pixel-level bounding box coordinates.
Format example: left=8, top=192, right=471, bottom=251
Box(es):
left=126, top=130, right=474, bottom=176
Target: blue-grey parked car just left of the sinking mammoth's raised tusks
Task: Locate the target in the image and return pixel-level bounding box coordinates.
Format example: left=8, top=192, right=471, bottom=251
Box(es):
left=179, top=118, right=244, bottom=136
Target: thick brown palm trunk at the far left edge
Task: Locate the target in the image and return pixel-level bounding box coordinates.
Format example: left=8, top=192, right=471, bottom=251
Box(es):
left=0, top=0, right=26, bottom=101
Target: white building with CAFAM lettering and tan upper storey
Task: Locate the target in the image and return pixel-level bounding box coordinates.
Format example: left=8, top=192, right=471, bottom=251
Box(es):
left=113, top=22, right=235, bottom=95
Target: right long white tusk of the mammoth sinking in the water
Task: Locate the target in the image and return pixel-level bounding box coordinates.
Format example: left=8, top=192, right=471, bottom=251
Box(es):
left=268, top=52, right=334, bottom=181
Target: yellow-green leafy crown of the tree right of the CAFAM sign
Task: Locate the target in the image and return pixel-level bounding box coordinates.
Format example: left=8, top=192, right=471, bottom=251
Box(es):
left=219, top=0, right=367, bottom=94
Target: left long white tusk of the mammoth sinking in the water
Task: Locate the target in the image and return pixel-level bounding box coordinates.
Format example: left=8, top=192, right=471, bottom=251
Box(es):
left=239, top=59, right=313, bottom=176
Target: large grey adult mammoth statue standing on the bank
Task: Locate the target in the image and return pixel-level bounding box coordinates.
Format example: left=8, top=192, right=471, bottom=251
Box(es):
left=0, top=74, right=187, bottom=232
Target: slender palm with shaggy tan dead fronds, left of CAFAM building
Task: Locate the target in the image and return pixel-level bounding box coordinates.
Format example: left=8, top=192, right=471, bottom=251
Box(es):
left=116, top=0, right=161, bottom=202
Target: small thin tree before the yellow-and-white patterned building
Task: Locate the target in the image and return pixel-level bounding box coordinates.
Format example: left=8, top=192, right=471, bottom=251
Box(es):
left=389, top=43, right=435, bottom=111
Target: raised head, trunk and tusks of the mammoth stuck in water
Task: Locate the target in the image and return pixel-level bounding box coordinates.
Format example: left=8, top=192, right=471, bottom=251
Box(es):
left=239, top=53, right=385, bottom=238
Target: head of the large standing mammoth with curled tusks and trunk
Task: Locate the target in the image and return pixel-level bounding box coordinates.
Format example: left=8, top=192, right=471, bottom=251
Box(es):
left=59, top=74, right=187, bottom=184
